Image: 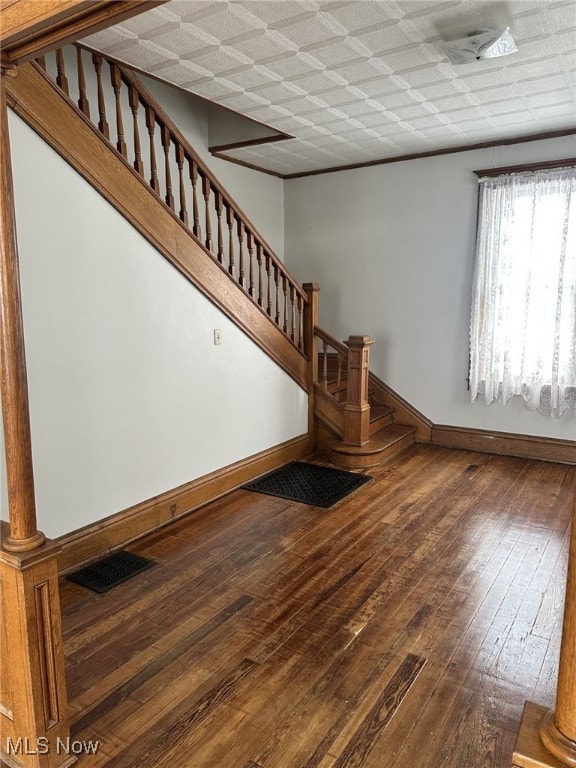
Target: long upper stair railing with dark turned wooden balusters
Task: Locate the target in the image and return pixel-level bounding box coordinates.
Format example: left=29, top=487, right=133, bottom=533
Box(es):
left=37, top=45, right=308, bottom=352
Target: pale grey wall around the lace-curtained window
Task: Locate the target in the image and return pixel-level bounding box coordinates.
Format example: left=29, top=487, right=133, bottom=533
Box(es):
left=285, top=136, right=576, bottom=439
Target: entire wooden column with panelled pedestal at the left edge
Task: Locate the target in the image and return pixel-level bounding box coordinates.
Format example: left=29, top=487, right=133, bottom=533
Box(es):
left=0, top=71, right=77, bottom=768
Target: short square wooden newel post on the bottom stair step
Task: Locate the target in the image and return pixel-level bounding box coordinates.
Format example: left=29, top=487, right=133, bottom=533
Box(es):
left=343, top=336, right=374, bottom=445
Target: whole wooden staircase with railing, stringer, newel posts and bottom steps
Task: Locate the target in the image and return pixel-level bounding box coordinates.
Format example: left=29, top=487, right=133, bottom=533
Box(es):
left=7, top=46, right=417, bottom=469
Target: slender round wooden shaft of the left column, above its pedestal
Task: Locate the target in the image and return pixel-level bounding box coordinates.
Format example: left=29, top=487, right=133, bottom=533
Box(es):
left=0, top=75, right=44, bottom=551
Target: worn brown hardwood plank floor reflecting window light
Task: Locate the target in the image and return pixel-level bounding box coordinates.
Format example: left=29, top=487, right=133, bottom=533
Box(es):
left=55, top=445, right=575, bottom=768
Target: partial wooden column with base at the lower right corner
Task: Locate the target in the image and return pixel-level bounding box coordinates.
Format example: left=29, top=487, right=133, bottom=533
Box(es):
left=513, top=476, right=576, bottom=768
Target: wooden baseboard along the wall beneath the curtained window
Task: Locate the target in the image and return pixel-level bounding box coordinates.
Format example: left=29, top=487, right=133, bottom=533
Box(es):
left=432, top=424, right=576, bottom=464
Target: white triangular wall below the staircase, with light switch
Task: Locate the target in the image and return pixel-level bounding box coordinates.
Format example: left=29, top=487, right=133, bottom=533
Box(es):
left=2, top=114, right=307, bottom=537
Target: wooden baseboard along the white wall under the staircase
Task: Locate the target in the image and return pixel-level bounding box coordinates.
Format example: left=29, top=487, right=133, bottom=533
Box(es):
left=54, top=434, right=311, bottom=573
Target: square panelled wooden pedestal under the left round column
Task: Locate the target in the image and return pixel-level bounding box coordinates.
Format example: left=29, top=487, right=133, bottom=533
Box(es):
left=0, top=543, right=76, bottom=768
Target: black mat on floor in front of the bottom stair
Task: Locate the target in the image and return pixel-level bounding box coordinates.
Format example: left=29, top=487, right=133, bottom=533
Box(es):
left=242, top=461, right=372, bottom=508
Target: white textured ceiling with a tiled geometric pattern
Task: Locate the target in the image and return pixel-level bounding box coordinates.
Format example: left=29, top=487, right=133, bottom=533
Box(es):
left=83, top=0, right=576, bottom=175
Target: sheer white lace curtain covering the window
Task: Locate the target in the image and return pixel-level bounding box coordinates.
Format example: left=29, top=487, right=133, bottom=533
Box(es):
left=470, top=168, right=576, bottom=417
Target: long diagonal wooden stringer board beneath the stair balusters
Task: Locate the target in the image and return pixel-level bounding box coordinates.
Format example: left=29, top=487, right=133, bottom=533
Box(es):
left=4, top=63, right=308, bottom=391
